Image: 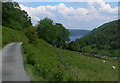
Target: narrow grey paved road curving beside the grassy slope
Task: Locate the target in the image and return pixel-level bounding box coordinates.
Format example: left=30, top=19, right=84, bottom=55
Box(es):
left=2, top=43, right=30, bottom=81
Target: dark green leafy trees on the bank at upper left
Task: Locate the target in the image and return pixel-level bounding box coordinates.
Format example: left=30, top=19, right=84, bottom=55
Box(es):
left=2, top=2, right=32, bottom=30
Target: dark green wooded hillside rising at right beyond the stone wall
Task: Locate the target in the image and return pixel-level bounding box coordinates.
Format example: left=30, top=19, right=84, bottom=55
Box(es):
left=75, top=20, right=120, bottom=57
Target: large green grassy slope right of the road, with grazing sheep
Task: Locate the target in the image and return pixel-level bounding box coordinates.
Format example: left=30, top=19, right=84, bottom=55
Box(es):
left=22, top=40, right=118, bottom=81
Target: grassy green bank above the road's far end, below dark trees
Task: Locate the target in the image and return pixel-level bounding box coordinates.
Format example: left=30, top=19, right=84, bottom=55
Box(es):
left=0, top=26, right=28, bottom=46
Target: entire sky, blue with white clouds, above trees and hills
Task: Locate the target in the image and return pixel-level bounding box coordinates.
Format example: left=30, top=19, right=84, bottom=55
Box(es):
left=19, top=0, right=119, bottom=30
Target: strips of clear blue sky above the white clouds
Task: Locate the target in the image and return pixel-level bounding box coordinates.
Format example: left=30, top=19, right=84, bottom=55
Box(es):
left=19, top=2, right=118, bottom=8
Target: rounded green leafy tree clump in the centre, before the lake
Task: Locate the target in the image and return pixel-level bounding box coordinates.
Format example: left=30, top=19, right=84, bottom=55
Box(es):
left=37, top=18, right=69, bottom=47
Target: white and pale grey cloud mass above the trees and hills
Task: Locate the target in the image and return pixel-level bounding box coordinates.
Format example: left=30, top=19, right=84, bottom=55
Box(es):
left=20, top=0, right=118, bottom=29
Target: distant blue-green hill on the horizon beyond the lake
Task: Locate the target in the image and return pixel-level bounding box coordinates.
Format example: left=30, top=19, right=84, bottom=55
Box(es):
left=69, top=29, right=90, bottom=36
